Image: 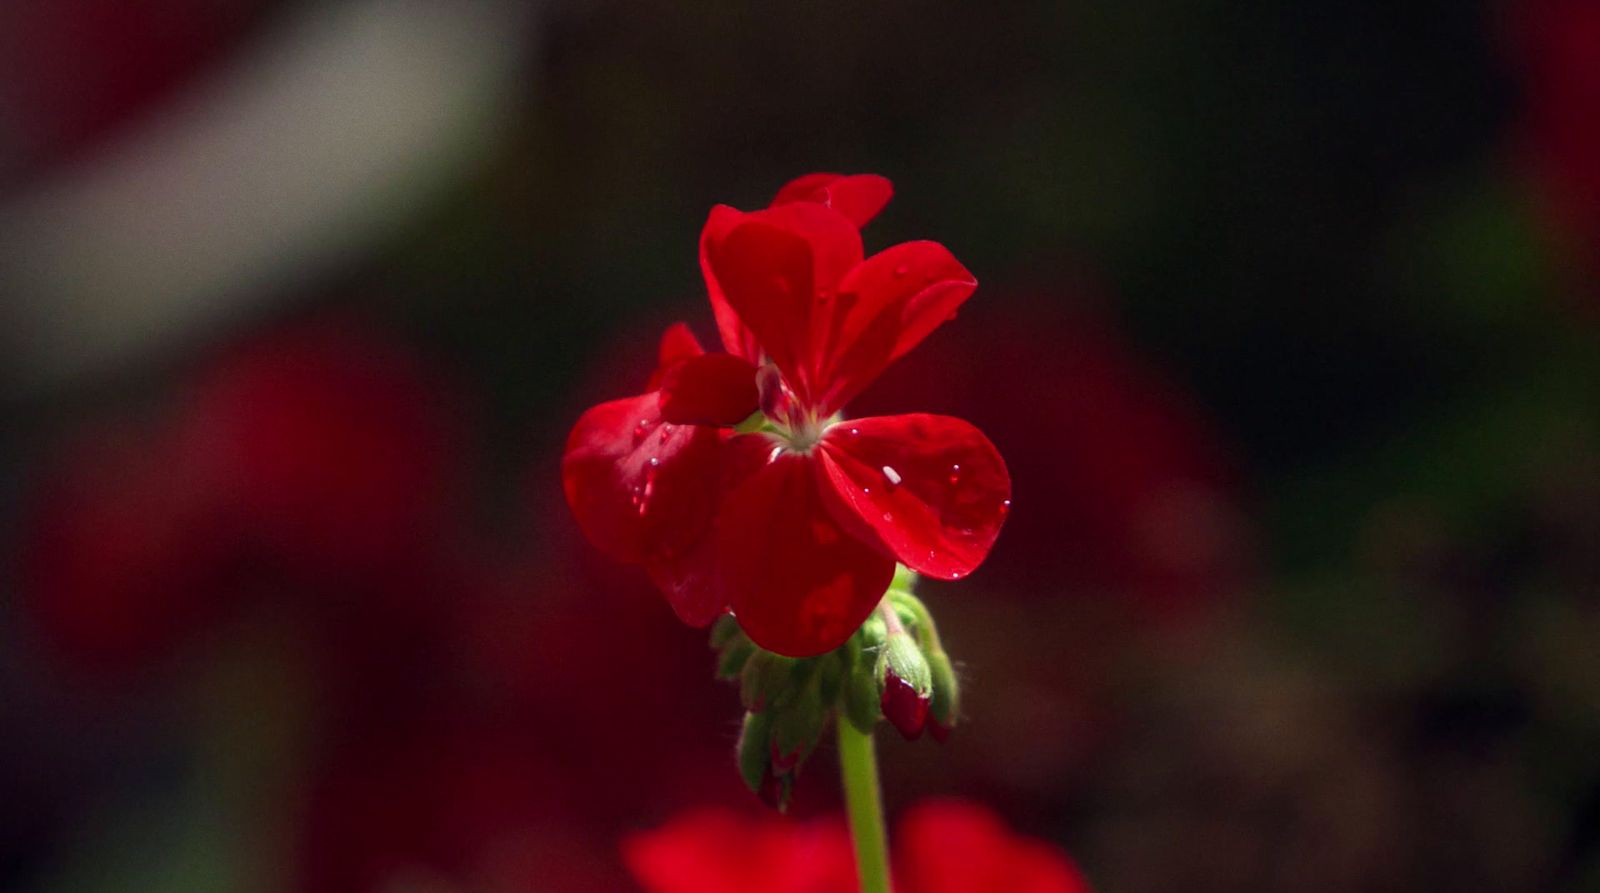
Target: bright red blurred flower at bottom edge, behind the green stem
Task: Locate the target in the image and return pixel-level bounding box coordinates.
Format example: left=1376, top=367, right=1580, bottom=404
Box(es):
left=622, top=800, right=1090, bottom=893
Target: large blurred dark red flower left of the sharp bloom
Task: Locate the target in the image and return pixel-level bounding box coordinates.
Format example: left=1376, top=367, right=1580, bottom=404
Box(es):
left=21, top=323, right=461, bottom=669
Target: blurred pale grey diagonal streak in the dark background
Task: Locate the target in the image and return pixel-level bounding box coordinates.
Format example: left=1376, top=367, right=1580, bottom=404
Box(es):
left=0, top=0, right=533, bottom=395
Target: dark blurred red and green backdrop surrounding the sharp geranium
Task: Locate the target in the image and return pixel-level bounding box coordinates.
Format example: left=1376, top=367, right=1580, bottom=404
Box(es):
left=0, top=0, right=1600, bottom=893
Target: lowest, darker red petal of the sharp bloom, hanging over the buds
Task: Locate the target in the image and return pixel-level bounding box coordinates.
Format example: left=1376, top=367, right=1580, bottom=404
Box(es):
left=717, top=448, right=894, bottom=658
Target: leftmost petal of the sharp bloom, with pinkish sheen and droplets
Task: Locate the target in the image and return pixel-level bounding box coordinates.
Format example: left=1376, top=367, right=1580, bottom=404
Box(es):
left=562, top=392, right=720, bottom=576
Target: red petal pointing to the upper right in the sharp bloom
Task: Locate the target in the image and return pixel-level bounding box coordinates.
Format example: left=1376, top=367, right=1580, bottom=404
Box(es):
left=818, top=242, right=978, bottom=414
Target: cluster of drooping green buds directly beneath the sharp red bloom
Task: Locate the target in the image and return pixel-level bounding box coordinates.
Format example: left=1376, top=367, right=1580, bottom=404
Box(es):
left=710, top=568, right=960, bottom=810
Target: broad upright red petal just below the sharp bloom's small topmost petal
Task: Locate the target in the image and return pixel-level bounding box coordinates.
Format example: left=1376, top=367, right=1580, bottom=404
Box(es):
left=707, top=202, right=861, bottom=403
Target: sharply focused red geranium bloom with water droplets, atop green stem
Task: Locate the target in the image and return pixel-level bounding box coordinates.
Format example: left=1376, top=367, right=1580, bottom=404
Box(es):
left=562, top=174, right=1011, bottom=656
